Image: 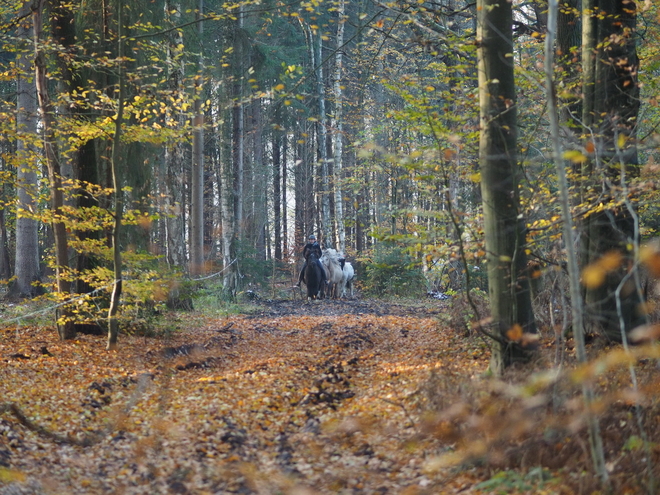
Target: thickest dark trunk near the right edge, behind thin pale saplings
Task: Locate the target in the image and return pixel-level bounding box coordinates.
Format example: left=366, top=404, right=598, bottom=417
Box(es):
left=582, top=0, right=645, bottom=340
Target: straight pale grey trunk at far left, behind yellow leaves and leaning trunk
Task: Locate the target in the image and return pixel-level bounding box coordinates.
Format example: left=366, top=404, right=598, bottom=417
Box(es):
left=11, top=2, right=41, bottom=297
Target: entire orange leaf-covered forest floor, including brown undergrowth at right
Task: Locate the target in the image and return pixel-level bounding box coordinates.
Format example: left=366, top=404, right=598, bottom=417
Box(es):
left=0, top=299, right=660, bottom=495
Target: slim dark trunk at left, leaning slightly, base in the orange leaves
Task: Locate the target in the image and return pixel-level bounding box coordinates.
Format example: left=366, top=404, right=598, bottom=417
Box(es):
left=32, top=0, right=76, bottom=340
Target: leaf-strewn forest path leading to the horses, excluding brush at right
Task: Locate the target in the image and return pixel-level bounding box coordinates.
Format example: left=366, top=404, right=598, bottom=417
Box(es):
left=0, top=300, right=488, bottom=494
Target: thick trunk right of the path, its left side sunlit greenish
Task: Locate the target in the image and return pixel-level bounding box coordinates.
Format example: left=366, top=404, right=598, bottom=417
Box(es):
left=477, top=0, right=536, bottom=374
